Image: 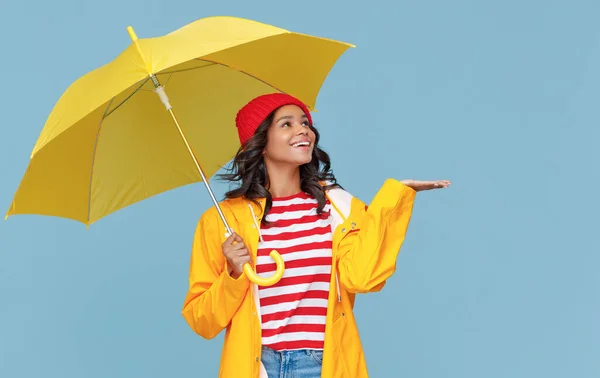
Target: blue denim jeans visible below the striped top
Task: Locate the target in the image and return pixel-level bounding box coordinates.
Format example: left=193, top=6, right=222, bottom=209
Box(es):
left=261, top=346, right=323, bottom=378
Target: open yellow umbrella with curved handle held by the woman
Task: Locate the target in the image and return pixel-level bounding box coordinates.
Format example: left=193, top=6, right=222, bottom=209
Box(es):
left=6, top=17, right=352, bottom=285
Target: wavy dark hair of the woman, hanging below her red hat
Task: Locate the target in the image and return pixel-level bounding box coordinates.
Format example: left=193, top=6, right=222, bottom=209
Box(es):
left=218, top=111, right=341, bottom=224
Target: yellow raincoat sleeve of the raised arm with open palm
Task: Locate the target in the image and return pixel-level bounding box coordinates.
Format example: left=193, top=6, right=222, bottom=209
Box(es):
left=338, top=179, right=416, bottom=293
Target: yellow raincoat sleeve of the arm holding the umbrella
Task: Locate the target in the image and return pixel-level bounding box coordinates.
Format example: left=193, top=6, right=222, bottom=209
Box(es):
left=182, top=210, right=250, bottom=339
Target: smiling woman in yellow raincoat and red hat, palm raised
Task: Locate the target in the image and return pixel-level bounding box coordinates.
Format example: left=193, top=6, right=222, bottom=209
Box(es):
left=183, top=93, right=450, bottom=378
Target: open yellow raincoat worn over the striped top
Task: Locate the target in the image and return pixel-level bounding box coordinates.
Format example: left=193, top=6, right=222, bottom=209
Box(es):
left=182, top=179, right=415, bottom=378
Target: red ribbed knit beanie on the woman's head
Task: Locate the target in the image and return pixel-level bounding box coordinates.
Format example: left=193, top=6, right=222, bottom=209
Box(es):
left=235, top=93, right=312, bottom=145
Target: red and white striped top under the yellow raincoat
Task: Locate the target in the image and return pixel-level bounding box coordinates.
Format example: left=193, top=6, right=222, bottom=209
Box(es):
left=256, top=193, right=332, bottom=350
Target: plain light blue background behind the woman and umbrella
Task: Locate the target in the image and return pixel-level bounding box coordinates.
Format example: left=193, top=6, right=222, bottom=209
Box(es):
left=0, top=0, right=600, bottom=378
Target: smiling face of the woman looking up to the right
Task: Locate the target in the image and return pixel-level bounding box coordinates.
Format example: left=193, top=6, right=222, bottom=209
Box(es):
left=264, top=105, right=315, bottom=166
